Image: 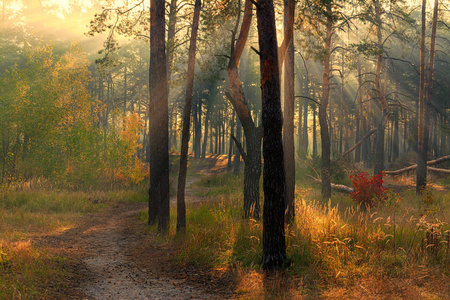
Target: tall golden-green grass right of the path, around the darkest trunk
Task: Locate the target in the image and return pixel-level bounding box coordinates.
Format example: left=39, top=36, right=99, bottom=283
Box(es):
left=141, top=169, right=450, bottom=297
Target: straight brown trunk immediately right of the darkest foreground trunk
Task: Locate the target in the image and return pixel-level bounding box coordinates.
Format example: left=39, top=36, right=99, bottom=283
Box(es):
left=283, top=0, right=295, bottom=222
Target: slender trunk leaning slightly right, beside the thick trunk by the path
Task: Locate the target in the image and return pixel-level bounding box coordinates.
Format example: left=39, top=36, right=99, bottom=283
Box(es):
left=177, top=0, right=202, bottom=232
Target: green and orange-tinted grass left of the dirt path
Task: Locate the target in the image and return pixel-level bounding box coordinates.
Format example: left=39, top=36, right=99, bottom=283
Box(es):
left=0, top=185, right=148, bottom=299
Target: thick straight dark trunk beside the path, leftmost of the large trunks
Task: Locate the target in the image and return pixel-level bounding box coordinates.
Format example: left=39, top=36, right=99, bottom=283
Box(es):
left=149, top=0, right=170, bottom=231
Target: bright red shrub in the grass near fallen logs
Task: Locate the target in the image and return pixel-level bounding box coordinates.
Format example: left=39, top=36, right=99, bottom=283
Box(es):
left=350, top=172, right=387, bottom=209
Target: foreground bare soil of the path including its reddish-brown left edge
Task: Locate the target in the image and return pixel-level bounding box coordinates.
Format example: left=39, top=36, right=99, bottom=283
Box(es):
left=41, top=204, right=216, bottom=299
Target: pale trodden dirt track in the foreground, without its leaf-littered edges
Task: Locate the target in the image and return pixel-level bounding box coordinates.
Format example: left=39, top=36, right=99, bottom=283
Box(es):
left=75, top=205, right=210, bottom=299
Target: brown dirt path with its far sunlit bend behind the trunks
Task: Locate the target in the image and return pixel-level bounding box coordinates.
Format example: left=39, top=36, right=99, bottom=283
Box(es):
left=38, top=156, right=226, bottom=299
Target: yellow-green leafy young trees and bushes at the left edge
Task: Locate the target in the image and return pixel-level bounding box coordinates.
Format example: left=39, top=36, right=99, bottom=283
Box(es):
left=0, top=44, right=148, bottom=189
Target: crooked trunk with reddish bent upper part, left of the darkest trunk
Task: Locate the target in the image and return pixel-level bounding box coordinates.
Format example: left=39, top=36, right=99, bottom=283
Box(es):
left=227, top=0, right=262, bottom=219
